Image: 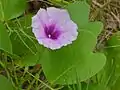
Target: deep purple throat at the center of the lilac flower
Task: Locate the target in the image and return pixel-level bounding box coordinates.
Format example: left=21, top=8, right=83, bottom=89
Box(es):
left=44, top=24, right=60, bottom=40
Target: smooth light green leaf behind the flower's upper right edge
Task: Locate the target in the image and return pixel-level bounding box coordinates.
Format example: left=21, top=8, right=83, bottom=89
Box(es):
left=66, top=2, right=90, bottom=27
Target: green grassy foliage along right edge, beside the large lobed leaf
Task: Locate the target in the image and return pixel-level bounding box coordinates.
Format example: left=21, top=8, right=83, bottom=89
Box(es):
left=93, top=32, right=120, bottom=90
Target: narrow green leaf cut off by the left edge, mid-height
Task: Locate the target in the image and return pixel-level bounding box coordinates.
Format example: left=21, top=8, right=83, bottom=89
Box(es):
left=0, top=23, right=12, bottom=53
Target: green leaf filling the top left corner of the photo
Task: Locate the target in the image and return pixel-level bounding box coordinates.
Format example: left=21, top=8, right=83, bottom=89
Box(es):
left=0, top=0, right=26, bottom=21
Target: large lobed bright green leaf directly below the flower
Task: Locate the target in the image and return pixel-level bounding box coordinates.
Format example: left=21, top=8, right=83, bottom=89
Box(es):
left=41, top=23, right=106, bottom=84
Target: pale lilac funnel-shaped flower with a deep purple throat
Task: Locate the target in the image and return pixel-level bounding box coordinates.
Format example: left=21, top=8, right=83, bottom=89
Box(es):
left=32, top=7, right=78, bottom=50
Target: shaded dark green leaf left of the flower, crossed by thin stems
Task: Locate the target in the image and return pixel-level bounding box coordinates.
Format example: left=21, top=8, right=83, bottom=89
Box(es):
left=10, top=15, right=42, bottom=66
